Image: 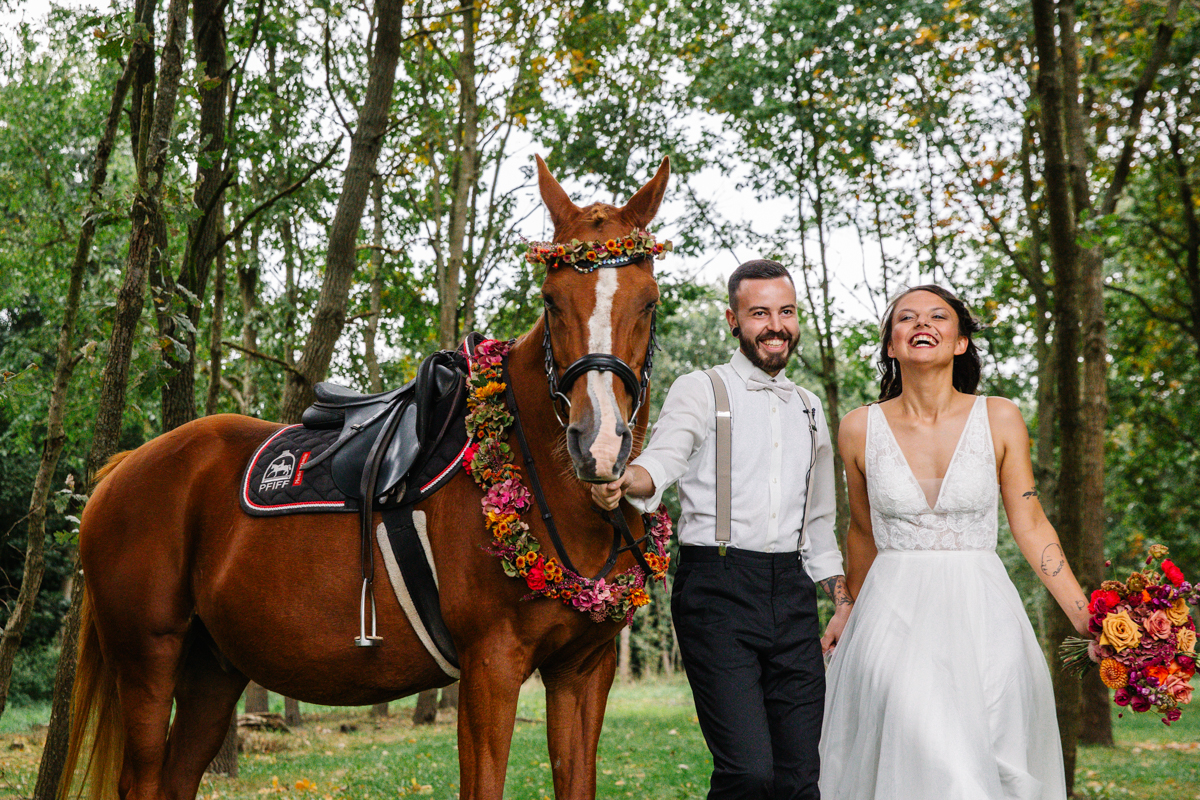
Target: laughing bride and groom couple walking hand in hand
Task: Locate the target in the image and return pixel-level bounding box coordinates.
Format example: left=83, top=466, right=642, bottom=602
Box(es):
left=593, top=260, right=1087, bottom=800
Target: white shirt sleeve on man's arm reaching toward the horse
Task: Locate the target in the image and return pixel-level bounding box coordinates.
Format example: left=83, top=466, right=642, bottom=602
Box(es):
left=625, top=372, right=713, bottom=513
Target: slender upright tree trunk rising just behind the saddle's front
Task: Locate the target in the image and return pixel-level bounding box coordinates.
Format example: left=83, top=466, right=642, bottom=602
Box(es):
left=438, top=0, right=479, bottom=350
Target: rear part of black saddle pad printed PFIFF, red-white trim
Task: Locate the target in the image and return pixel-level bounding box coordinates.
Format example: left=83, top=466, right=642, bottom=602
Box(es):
left=239, top=425, right=358, bottom=517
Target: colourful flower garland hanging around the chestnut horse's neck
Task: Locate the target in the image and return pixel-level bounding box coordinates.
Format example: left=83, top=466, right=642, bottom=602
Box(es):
left=463, top=339, right=671, bottom=622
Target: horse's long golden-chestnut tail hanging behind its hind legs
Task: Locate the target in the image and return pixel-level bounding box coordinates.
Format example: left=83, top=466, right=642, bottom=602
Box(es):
left=58, top=592, right=125, bottom=800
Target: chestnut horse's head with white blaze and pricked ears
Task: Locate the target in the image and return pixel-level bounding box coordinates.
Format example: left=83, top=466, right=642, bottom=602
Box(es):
left=538, top=157, right=671, bottom=482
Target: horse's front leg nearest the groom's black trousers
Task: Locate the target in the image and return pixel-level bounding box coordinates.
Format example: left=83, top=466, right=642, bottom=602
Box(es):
left=541, top=643, right=617, bottom=800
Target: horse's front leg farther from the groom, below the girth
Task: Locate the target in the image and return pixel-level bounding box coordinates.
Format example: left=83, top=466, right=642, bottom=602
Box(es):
left=458, top=642, right=524, bottom=800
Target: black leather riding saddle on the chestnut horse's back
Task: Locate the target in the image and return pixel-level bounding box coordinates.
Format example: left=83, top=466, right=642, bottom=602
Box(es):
left=300, top=350, right=468, bottom=503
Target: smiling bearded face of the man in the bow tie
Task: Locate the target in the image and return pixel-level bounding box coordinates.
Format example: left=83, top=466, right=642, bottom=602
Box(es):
left=725, top=277, right=800, bottom=375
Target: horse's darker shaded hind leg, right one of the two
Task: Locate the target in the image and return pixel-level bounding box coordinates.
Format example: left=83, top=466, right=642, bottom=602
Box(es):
left=163, top=620, right=250, bottom=800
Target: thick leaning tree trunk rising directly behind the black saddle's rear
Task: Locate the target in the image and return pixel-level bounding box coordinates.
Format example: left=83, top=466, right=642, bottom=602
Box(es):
left=281, top=0, right=403, bottom=422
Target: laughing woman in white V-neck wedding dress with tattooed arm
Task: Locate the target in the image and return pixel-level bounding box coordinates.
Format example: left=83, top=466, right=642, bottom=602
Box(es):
left=821, top=285, right=1087, bottom=800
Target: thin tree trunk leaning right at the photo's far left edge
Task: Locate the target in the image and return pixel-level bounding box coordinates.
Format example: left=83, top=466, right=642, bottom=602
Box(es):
left=0, top=50, right=133, bottom=716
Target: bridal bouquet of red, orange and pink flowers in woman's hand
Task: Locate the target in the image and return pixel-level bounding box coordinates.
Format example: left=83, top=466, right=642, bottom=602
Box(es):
left=1062, top=545, right=1200, bottom=724
